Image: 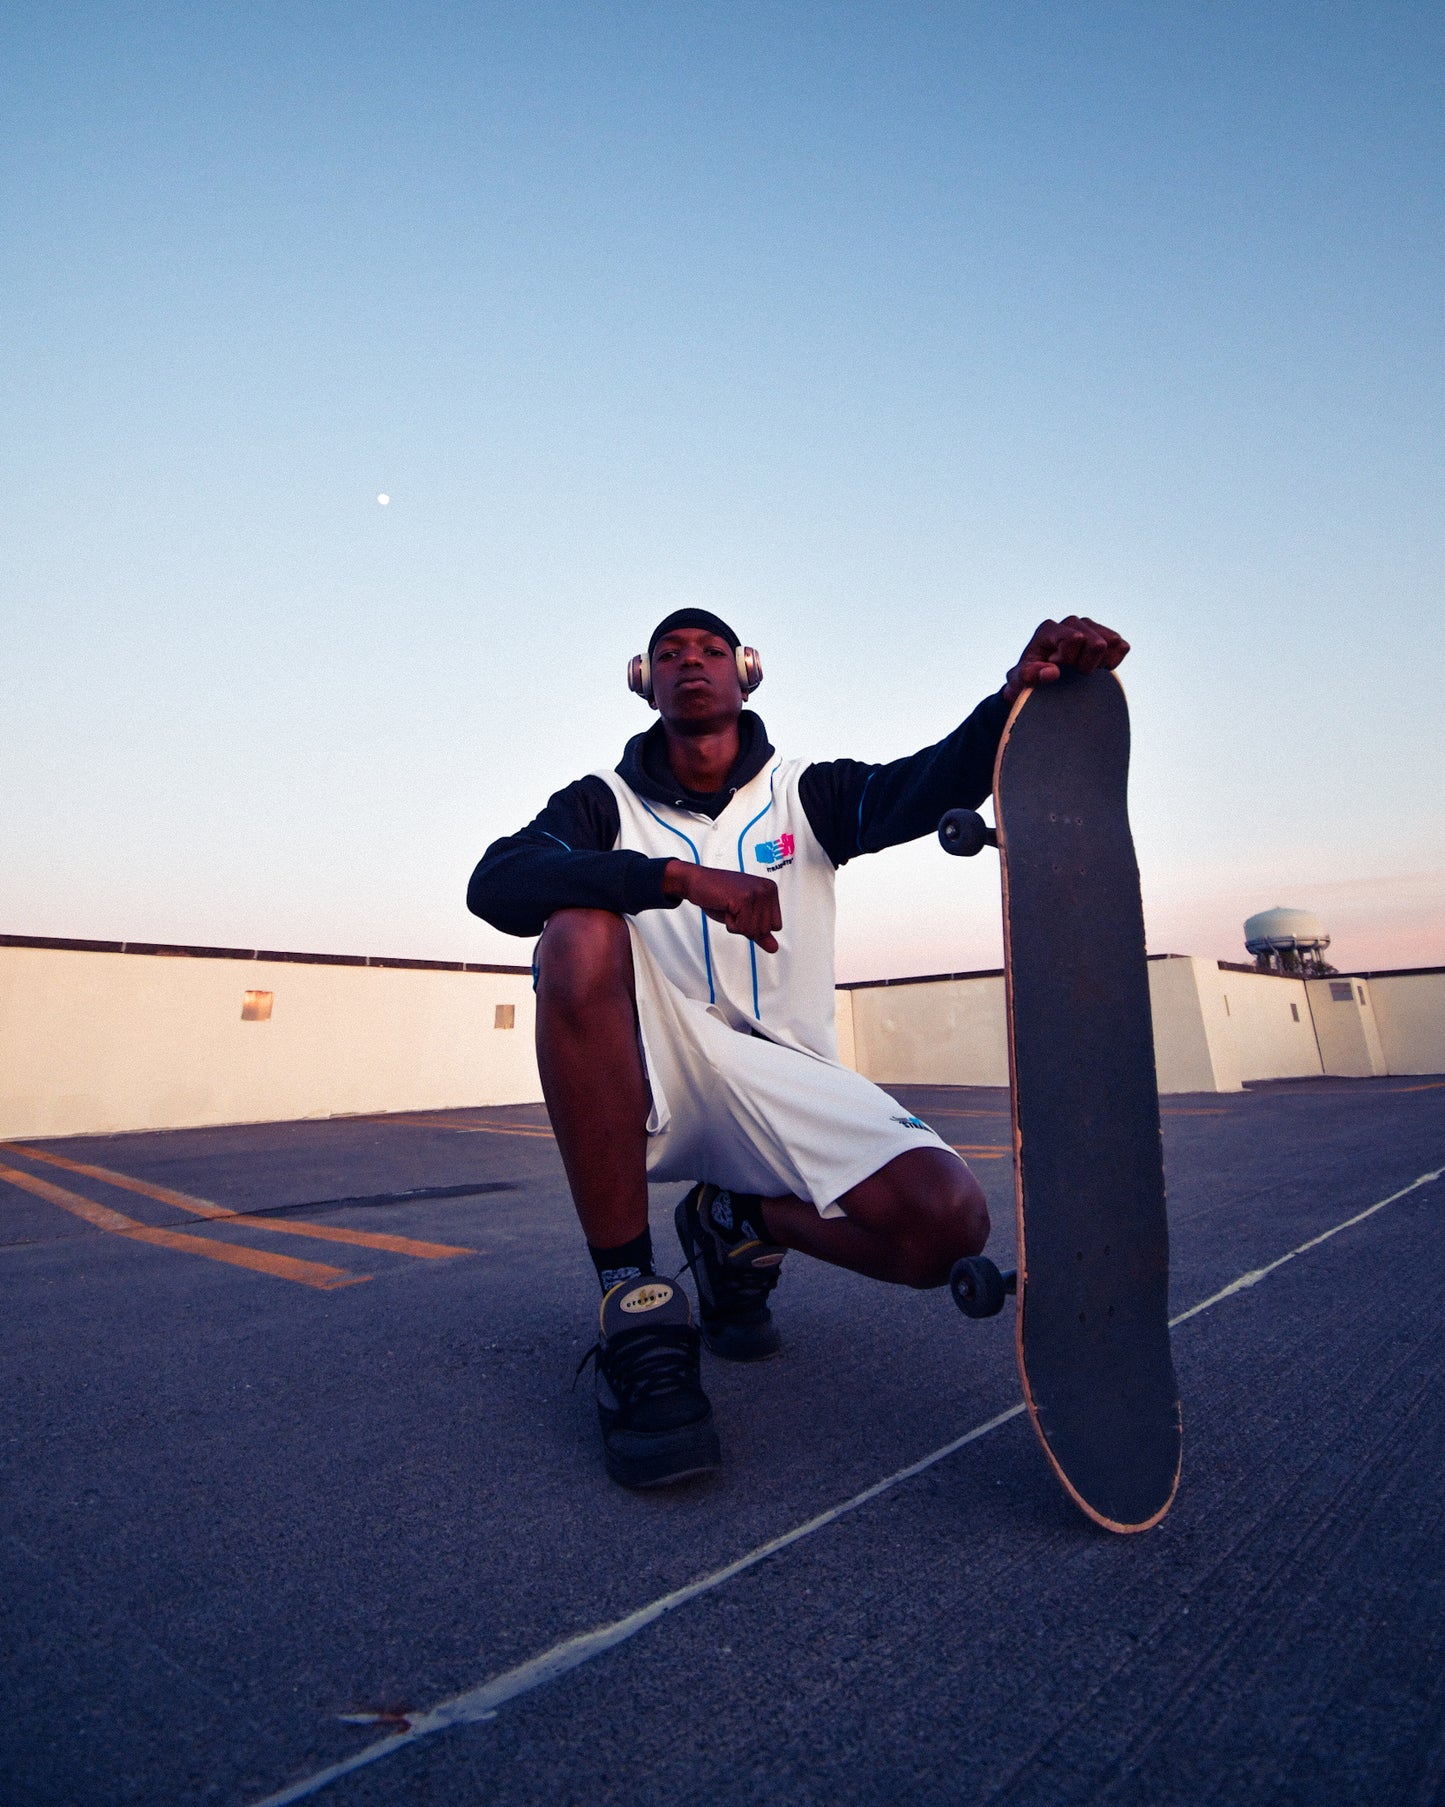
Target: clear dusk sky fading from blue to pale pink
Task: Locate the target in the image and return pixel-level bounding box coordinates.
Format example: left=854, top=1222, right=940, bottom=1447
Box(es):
left=0, top=0, right=1445, bottom=978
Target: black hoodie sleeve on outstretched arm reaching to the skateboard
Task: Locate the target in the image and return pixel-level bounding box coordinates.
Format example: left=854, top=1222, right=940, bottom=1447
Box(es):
left=798, top=690, right=1010, bottom=866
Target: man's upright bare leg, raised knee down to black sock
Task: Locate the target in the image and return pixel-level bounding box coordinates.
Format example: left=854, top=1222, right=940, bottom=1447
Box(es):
left=536, top=909, right=650, bottom=1249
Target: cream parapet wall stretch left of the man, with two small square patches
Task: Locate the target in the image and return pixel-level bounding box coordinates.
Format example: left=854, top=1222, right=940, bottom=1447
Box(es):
left=0, top=947, right=542, bottom=1137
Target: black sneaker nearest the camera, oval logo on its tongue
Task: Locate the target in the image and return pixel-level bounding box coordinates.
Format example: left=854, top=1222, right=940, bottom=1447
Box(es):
left=578, top=1279, right=723, bottom=1487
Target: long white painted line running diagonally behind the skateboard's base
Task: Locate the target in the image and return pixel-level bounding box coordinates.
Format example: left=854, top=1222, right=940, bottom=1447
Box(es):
left=251, top=1167, right=1445, bottom=1807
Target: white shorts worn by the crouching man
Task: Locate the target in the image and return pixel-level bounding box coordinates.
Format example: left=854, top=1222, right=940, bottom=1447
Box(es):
left=629, top=923, right=957, bottom=1218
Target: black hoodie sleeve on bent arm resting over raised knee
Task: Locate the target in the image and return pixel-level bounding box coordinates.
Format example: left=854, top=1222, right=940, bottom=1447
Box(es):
left=466, top=777, right=679, bottom=934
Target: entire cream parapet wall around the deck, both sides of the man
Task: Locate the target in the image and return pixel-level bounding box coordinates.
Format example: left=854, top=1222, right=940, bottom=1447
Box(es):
left=0, top=943, right=1445, bottom=1137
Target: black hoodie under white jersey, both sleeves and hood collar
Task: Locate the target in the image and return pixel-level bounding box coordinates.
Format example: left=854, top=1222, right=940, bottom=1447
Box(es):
left=466, top=692, right=1010, bottom=936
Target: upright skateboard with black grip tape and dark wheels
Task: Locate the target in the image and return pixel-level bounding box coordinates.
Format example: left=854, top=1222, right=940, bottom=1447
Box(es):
left=939, top=669, right=1179, bottom=1531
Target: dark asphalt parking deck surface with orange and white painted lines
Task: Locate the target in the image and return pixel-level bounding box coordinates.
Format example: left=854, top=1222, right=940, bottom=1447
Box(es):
left=0, top=1079, right=1445, bottom=1807
